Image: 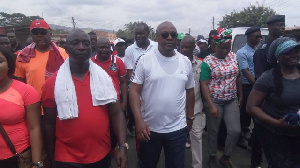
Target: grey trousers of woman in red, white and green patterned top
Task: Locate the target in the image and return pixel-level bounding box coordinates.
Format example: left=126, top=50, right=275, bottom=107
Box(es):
left=205, top=99, right=241, bottom=156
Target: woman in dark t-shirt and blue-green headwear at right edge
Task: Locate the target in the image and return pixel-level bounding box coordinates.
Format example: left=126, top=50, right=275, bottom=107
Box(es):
left=247, top=37, right=300, bottom=168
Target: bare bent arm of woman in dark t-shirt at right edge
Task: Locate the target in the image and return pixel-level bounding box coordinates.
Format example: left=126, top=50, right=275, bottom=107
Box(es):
left=246, top=89, right=287, bottom=127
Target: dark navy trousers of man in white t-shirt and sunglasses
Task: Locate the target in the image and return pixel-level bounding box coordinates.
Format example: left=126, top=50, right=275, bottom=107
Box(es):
left=138, top=127, right=187, bottom=168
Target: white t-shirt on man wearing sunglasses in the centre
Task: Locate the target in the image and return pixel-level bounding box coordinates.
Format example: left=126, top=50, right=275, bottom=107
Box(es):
left=132, top=49, right=195, bottom=133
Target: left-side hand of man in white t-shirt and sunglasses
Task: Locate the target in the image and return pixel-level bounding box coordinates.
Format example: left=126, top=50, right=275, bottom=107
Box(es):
left=135, top=119, right=150, bottom=141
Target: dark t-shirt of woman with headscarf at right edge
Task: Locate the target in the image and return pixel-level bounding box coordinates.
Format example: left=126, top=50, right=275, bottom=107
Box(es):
left=253, top=69, right=300, bottom=136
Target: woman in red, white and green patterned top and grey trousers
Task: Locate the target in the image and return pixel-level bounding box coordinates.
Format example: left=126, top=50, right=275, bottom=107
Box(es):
left=200, top=28, right=243, bottom=168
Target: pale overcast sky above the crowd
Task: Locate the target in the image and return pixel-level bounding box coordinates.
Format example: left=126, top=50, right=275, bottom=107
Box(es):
left=0, top=0, right=300, bottom=36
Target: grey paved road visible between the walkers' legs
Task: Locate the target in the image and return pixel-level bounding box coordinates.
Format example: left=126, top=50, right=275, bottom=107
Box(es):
left=111, top=133, right=267, bottom=168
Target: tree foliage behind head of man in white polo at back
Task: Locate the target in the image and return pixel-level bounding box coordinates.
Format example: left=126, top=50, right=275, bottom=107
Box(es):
left=116, top=21, right=155, bottom=39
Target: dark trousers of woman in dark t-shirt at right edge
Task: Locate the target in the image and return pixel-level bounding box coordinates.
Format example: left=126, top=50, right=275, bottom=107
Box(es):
left=255, top=123, right=300, bottom=168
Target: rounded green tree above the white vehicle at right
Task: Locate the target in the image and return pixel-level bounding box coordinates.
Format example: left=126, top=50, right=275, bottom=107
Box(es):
left=218, top=5, right=276, bottom=28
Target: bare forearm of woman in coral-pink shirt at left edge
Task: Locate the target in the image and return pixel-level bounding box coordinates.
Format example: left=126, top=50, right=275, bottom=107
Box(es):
left=25, top=102, right=42, bottom=162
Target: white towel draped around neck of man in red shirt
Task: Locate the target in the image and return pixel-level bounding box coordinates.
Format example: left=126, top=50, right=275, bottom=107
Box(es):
left=54, top=58, right=117, bottom=120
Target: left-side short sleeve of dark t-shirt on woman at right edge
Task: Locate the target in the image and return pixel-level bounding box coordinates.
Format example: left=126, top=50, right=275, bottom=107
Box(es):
left=253, top=70, right=274, bottom=93
